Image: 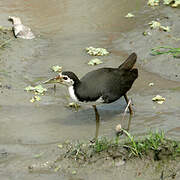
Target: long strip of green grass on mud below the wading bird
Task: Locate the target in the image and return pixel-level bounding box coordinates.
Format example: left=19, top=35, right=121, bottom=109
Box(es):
left=65, top=130, right=180, bottom=162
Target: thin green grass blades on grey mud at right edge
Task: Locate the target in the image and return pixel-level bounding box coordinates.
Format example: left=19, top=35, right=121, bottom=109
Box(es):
left=151, top=46, right=180, bottom=57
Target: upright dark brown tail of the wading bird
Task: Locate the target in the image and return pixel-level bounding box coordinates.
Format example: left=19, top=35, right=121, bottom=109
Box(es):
left=119, top=53, right=137, bottom=70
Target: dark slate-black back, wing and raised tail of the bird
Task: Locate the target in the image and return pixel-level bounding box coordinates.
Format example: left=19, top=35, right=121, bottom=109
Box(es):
left=75, top=53, right=138, bottom=103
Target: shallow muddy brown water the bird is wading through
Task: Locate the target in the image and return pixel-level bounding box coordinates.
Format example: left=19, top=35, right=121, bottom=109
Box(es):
left=0, top=0, right=180, bottom=179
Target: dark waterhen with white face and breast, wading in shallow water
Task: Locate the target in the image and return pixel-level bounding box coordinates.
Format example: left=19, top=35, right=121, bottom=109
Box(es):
left=44, top=52, right=138, bottom=122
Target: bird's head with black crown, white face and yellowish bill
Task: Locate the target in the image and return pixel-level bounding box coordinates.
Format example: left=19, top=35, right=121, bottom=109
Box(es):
left=44, top=71, right=79, bottom=87
